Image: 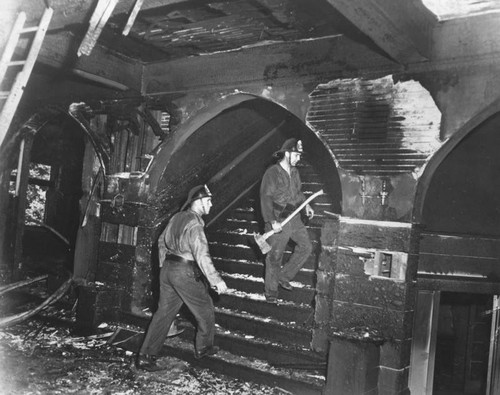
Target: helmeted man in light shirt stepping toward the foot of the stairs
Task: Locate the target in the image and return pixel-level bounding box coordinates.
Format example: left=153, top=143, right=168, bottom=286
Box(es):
left=136, top=185, right=227, bottom=371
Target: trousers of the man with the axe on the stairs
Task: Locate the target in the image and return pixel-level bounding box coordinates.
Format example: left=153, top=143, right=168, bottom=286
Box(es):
left=264, top=216, right=312, bottom=296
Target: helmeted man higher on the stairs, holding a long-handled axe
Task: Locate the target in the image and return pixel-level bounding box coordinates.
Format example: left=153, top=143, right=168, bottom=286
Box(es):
left=260, top=138, right=314, bottom=303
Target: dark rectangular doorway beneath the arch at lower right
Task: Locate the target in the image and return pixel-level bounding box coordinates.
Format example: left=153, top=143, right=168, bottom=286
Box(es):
left=433, top=292, right=493, bottom=395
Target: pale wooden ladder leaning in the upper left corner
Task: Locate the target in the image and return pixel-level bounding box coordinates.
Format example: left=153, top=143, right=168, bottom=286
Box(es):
left=0, top=8, right=54, bottom=145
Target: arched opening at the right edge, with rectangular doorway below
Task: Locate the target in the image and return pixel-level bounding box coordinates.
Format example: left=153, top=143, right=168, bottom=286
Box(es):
left=412, top=113, right=500, bottom=394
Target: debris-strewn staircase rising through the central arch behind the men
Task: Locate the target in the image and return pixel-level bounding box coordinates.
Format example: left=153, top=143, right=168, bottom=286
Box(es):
left=119, top=160, right=331, bottom=395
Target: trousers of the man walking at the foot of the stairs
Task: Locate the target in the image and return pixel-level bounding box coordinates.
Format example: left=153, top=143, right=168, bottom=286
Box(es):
left=140, top=260, right=215, bottom=355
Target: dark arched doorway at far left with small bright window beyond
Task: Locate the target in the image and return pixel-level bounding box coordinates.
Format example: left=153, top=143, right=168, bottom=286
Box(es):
left=0, top=108, right=97, bottom=279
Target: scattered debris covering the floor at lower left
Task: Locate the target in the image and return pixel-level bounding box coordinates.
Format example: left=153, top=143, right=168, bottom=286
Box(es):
left=0, top=317, right=286, bottom=395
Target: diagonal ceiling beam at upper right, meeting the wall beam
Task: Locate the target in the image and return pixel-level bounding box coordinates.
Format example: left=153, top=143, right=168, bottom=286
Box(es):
left=327, top=0, right=437, bottom=64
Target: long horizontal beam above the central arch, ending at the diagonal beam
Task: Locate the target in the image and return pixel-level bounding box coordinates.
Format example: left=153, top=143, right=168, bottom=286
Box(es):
left=143, top=35, right=402, bottom=95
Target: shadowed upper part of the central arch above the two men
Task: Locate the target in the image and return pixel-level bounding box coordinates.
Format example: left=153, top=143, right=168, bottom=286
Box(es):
left=143, top=94, right=341, bottom=235
